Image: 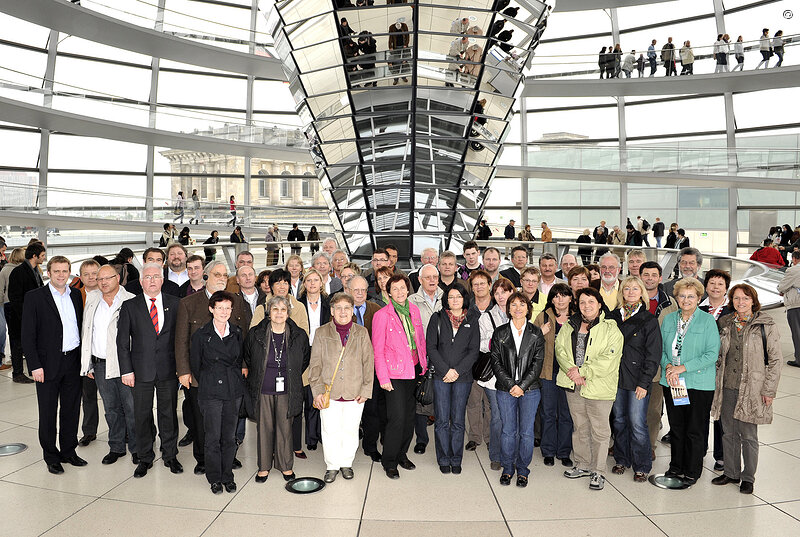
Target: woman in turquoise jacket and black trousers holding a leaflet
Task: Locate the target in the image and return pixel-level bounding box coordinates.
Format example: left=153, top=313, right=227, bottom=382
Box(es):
left=661, top=278, right=719, bottom=485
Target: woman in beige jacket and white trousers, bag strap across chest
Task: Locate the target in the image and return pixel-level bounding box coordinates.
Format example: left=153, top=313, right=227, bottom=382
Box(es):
left=308, top=293, right=375, bottom=483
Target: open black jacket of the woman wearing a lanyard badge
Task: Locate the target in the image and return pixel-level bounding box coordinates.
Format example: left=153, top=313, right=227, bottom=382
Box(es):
left=243, top=318, right=311, bottom=421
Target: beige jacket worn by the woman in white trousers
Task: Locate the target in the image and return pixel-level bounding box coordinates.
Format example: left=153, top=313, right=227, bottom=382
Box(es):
left=308, top=321, right=375, bottom=401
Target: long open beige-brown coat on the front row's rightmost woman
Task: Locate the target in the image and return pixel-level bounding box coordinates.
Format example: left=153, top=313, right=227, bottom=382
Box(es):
left=711, top=311, right=782, bottom=425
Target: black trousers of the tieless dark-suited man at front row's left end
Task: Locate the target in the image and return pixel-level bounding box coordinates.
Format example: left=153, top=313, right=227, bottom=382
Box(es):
left=36, top=347, right=81, bottom=464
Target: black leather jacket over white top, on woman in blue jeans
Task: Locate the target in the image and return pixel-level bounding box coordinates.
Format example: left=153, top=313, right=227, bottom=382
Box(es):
left=491, top=321, right=544, bottom=392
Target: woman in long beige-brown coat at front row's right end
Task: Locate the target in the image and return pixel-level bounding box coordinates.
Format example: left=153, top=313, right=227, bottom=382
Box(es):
left=711, top=283, right=781, bottom=494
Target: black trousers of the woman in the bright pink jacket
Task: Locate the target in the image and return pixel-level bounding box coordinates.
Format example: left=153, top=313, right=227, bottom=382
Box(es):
left=381, top=379, right=417, bottom=470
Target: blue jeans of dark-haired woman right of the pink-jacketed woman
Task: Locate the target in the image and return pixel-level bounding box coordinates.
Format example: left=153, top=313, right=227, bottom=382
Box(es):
left=433, top=380, right=472, bottom=466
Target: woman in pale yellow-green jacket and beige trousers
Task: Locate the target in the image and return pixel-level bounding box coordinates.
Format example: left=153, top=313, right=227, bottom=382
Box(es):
left=555, top=287, right=623, bottom=490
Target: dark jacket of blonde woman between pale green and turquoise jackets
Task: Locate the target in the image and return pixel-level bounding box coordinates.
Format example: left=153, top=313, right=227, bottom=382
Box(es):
left=606, top=306, right=661, bottom=392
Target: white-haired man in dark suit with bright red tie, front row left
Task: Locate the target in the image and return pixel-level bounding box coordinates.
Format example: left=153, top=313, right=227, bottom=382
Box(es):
left=117, top=263, right=183, bottom=477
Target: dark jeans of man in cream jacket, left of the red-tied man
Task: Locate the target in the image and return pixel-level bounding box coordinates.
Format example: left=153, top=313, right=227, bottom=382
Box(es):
left=94, top=360, right=137, bottom=454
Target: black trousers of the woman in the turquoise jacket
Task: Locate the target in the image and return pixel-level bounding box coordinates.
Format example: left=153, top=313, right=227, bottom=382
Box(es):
left=662, top=386, right=714, bottom=479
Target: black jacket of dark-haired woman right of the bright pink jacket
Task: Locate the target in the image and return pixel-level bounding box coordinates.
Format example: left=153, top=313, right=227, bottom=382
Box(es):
left=425, top=306, right=481, bottom=382
